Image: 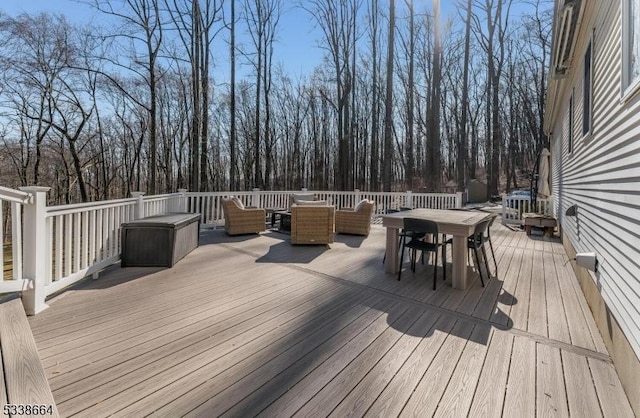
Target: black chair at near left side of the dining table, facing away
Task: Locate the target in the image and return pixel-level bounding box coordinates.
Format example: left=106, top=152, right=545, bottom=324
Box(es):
left=398, top=218, right=447, bottom=290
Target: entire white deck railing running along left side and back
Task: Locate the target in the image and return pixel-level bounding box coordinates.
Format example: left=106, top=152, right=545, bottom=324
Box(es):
left=0, top=187, right=462, bottom=315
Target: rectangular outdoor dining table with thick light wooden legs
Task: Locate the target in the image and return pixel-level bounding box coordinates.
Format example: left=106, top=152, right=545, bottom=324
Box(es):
left=382, top=209, right=491, bottom=289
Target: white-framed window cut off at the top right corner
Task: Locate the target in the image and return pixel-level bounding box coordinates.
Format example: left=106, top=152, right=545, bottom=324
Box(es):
left=622, top=0, right=640, bottom=95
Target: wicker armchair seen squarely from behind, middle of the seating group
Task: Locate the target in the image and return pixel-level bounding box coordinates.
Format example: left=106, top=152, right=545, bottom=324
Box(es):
left=291, top=205, right=335, bottom=244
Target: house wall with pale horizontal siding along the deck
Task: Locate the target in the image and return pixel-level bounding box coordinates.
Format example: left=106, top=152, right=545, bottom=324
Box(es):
left=547, top=0, right=640, bottom=415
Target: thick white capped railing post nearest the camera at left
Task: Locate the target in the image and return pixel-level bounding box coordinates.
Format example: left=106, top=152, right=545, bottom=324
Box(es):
left=20, top=186, right=51, bottom=315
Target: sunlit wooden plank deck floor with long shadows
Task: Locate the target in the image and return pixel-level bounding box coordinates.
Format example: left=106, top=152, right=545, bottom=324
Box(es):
left=30, top=220, right=633, bottom=417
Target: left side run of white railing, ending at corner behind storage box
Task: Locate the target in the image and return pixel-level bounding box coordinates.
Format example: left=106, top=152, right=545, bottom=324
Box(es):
left=0, top=187, right=186, bottom=314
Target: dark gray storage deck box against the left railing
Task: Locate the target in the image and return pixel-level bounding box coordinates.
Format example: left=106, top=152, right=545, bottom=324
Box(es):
left=121, top=213, right=200, bottom=267
